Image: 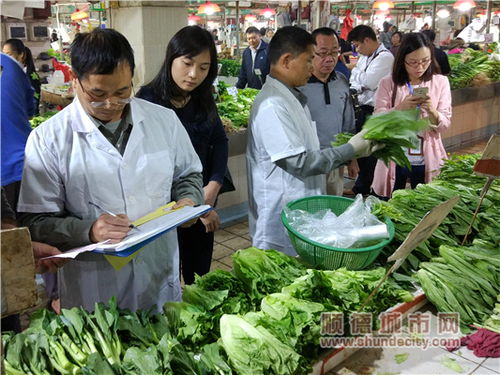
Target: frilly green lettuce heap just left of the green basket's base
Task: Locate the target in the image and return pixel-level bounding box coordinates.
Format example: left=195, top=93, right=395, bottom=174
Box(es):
left=233, top=247, right=306, bottom=304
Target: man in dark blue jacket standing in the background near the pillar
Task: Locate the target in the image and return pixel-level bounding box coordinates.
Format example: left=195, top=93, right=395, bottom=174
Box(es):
left=236, top=26, right=269, bottom=89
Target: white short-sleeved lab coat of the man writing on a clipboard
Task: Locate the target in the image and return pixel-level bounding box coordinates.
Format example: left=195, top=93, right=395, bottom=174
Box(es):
left=18, top=98, right=202, bottom=311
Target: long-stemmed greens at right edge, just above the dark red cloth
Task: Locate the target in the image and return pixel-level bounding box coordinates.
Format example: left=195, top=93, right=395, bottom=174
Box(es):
left=416, top=240, right=500, bottom=332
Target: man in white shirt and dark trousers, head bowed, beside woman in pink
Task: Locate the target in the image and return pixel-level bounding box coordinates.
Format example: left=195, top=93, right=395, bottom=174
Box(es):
left=348, top=25, right=394, bottom=195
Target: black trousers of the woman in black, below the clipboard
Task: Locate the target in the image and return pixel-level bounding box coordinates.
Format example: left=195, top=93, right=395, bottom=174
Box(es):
left=177, top=220, right=214, bottom=284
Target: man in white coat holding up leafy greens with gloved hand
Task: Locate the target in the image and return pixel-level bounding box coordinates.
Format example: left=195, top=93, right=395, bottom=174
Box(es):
left=247, top=26, right=380, bottom=255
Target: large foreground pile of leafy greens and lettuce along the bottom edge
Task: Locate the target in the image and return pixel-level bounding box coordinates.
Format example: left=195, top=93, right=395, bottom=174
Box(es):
left=2, top=248, right=413, bottom=375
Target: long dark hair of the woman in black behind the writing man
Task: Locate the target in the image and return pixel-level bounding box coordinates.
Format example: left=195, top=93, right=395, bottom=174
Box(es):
left=141, top=26, right=217, bottom=116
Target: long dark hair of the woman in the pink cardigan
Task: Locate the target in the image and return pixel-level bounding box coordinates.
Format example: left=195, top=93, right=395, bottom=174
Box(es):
left=392, top=33, right=441, bottom=86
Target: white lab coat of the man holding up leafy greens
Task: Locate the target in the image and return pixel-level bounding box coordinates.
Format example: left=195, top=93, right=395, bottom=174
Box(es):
left=247, top=76, right=325, bottom=255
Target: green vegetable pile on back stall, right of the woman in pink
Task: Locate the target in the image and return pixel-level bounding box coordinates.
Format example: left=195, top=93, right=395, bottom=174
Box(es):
left=448, top=48, right=500, bottom=90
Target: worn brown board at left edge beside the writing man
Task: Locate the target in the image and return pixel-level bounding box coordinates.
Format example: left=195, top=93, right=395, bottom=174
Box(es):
left=0, top=228, right=37, bottom=318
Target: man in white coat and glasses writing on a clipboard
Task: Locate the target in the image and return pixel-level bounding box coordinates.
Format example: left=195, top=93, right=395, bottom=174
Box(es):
left=18, top=29, right=203, bottom=310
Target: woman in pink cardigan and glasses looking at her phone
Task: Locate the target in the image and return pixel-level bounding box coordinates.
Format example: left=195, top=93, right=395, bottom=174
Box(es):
left=372, top=33, right=451, bottom=197
